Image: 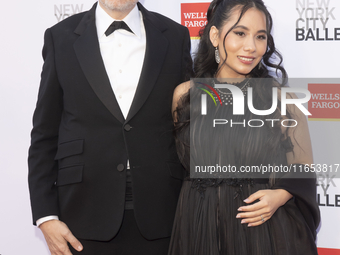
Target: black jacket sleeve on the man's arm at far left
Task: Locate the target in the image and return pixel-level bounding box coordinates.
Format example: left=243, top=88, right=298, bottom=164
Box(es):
left=28, top=29, right=63, bottom=224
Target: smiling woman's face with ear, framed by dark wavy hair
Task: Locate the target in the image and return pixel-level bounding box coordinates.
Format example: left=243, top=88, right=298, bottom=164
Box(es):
left=210, top=8, right=267, bottom=78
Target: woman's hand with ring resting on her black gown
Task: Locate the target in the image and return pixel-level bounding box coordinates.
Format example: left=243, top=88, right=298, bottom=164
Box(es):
left=236, top=189, right=293, bottom=227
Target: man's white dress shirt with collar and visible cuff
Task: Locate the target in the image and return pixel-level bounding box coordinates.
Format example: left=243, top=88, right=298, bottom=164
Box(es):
left=36, top=3, right=146, bottom=227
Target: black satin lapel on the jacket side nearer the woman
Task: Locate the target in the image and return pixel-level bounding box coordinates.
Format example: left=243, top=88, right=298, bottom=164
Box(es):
left=125, top=3, right=168, bottom=122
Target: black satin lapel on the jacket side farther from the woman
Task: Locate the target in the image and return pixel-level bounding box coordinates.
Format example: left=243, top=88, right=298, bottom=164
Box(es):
left=73, top=5, right=124, bottom=123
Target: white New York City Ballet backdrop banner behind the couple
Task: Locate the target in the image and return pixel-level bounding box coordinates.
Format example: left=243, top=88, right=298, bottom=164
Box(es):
left=0, top=0, right=340, bottom=255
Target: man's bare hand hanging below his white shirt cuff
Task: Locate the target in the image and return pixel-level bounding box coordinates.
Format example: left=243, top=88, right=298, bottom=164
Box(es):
left=39, top=220, right=83, bottom=255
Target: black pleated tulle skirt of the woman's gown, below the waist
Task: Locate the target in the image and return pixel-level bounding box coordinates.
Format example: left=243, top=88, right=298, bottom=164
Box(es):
left=169, top=180, right=317, bottom=255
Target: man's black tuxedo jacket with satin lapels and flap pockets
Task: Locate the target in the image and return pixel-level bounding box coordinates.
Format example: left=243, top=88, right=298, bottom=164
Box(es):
left=28, top=3, right=191, bottom=240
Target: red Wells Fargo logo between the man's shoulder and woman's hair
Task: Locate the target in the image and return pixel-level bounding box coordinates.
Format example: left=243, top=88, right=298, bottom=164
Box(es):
left=181, top=3, right=210, bottom=39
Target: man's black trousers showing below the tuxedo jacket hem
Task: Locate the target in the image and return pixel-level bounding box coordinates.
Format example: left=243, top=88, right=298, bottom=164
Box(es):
left=69, top=210, right=170, bottom=255
